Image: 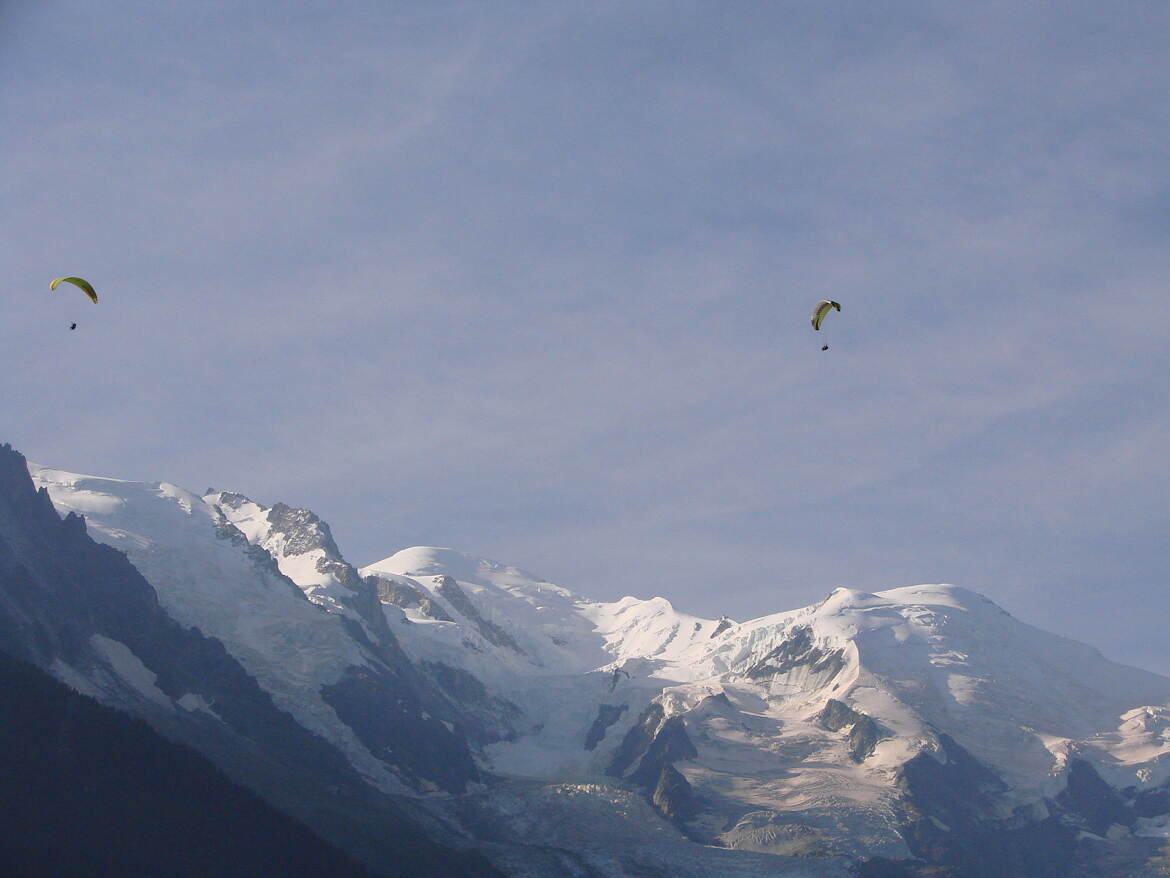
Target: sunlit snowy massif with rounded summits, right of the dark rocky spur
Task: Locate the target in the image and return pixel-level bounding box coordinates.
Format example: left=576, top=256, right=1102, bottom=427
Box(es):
left=362, top=548, right=1170, bottom=858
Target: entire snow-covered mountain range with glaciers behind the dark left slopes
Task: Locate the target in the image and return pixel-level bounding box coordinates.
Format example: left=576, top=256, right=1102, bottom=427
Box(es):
left=11, top=454, right=1170, bottom=876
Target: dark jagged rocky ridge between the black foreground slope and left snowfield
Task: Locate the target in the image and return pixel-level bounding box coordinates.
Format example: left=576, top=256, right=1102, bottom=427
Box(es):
left=0, top=445, right=500, bottom=878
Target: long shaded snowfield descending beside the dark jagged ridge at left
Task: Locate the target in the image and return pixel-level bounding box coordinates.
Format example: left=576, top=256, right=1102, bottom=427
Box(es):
left=29, top=464, right=416, bottom=791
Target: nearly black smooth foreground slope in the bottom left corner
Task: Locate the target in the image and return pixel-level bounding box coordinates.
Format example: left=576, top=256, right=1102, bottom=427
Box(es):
left=0, top=653, right=371, bottom=878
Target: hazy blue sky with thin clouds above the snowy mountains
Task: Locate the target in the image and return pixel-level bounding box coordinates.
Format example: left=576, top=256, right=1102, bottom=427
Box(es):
left=0, top=0, right=1170, bottom=673
